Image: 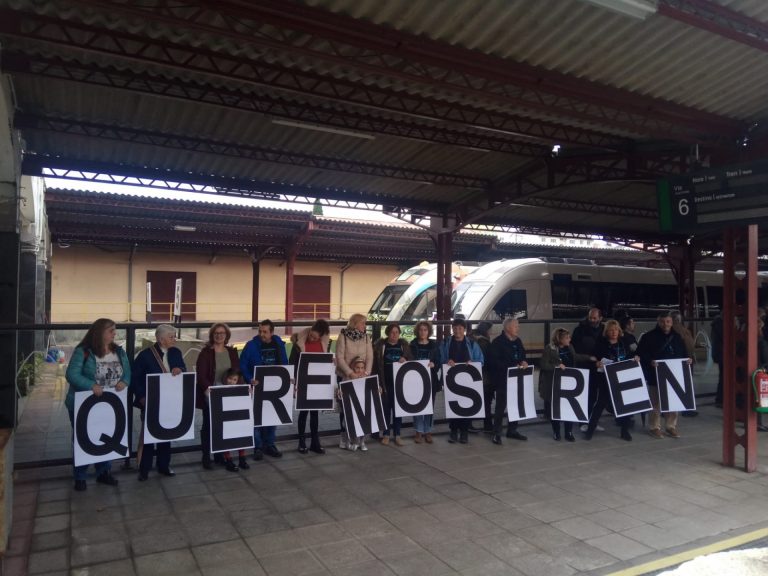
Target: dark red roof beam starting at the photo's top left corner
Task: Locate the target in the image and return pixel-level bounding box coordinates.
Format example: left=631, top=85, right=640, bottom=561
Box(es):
left=0, top=9, right=627, bottom=150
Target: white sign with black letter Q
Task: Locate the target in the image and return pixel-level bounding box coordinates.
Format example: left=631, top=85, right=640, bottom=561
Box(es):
left=73, top=388, right=128, bottom=466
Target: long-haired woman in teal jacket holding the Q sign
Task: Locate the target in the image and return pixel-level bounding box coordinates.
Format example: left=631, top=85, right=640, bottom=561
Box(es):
left=64, top=318, right=131, bottom=492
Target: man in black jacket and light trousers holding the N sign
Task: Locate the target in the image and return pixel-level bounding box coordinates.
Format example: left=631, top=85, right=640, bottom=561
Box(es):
left=637, top=312, right=693, bottom=439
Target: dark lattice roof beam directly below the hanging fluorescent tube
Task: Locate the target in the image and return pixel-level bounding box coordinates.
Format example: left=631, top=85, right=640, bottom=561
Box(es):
left=14, top=114, right=490, bottom=189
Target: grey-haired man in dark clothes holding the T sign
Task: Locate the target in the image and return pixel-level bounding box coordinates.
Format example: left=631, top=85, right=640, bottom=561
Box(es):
left=487, top=318, right=528, bottom=444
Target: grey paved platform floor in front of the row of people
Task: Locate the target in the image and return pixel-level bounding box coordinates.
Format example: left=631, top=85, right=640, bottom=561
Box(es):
left=5, top=364, right=768, bottom=576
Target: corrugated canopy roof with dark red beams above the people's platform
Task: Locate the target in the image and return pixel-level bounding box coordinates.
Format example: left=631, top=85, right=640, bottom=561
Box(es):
left=6, top=0, right=768, bottom=253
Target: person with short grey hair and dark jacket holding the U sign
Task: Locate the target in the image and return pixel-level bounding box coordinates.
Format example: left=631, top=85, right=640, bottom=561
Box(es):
left=131, top=324, right=187, bottom=482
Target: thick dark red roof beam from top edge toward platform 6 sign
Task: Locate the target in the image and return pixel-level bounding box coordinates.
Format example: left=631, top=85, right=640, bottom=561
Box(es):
left=51, top=0, right=742, bottom=140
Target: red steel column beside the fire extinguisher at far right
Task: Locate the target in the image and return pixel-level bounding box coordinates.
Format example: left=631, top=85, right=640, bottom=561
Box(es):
left=722, top=225, right=757, bottom=472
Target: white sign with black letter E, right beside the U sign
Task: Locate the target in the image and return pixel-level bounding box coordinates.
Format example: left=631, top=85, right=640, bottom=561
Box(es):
left=208, top=384, right=253, bottom=453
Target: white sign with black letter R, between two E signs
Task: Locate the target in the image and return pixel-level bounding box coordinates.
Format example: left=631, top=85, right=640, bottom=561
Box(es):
left=252, top=366, right=293, bottom=428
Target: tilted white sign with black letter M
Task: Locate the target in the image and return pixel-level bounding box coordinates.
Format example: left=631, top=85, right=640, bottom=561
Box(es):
left=339, top=376, right=387, bottom=439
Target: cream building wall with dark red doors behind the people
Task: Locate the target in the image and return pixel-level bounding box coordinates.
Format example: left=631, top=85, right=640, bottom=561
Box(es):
left=51, top=245, right=400, bottom=322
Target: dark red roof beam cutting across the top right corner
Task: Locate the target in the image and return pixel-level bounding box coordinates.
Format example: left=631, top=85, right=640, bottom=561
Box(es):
left=658, top=0, right=768, bottom=52
